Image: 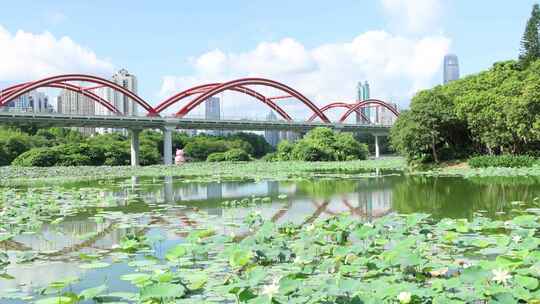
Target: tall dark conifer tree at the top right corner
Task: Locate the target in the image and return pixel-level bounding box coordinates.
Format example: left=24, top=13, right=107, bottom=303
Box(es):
left=519, top=4, right=540, bottom=67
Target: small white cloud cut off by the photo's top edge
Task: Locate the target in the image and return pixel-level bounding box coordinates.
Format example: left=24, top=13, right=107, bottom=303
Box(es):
left=381, top=0, right=443, bottom=33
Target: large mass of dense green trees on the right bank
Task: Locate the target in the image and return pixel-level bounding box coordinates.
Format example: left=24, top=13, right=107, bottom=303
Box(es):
left=391, top=61, right=540, bottom=162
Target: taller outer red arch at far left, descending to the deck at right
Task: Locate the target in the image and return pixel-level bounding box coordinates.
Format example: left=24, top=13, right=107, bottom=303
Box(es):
left=0, top=74, right=158, bottom=116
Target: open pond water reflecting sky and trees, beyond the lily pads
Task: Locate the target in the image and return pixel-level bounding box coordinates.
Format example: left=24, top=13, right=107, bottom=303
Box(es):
left=0, top=170, right=540, bottom=303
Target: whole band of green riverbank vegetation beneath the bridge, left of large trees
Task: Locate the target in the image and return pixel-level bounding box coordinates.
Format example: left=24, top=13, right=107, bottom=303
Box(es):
left=0, top=124, right=368, bottom=167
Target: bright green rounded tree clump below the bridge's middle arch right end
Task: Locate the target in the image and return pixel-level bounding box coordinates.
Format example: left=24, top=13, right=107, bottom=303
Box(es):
left=268, top=127, right=368, bottom=161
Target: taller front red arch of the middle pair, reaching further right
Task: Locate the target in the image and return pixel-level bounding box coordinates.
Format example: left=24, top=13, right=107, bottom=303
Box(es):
left=176, top=78, right=330, bottom=123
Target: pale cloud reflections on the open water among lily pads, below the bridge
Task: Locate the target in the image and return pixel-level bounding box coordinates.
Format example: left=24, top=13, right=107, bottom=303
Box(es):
left=0, top=178, right=392, bottom=291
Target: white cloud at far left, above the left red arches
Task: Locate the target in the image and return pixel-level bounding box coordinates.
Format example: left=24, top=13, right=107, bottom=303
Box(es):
left=0, top=26, right=113, bottom=82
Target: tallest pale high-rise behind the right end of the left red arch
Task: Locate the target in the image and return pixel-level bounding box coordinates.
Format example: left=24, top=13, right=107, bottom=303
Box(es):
left=95, top=69, right=138, bottom=134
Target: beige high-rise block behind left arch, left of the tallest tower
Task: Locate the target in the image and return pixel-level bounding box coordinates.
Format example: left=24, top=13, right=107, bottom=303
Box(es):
left=56, top=89, right=96, bottom=135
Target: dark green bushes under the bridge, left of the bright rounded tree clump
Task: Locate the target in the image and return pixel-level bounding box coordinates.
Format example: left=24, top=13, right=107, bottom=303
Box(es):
left=0, top=128, right=272, bottom=167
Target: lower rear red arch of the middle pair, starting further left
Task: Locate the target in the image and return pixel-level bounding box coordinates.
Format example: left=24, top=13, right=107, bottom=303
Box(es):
left=155, top=83, right=292, bottom=121
